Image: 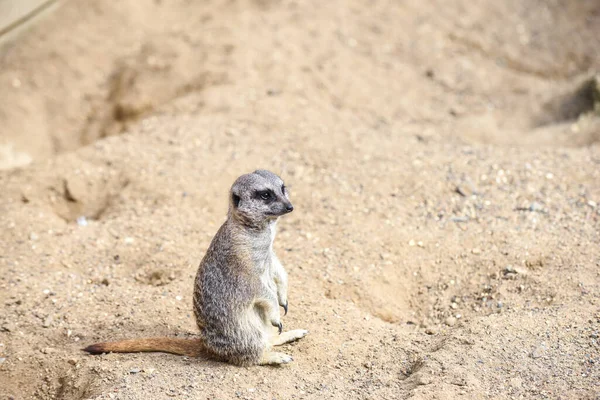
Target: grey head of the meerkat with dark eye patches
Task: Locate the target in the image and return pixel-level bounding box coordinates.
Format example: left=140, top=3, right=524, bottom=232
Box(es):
left=229, top=169, right=294, bottom=228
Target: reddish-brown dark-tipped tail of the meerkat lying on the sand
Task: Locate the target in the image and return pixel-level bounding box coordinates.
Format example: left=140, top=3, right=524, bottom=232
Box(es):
left=83, top=337, right=204, bottom=357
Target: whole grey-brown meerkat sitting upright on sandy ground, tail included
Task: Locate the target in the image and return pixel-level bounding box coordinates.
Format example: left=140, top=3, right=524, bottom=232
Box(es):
left=83, top=170, right=308, bottom=366
